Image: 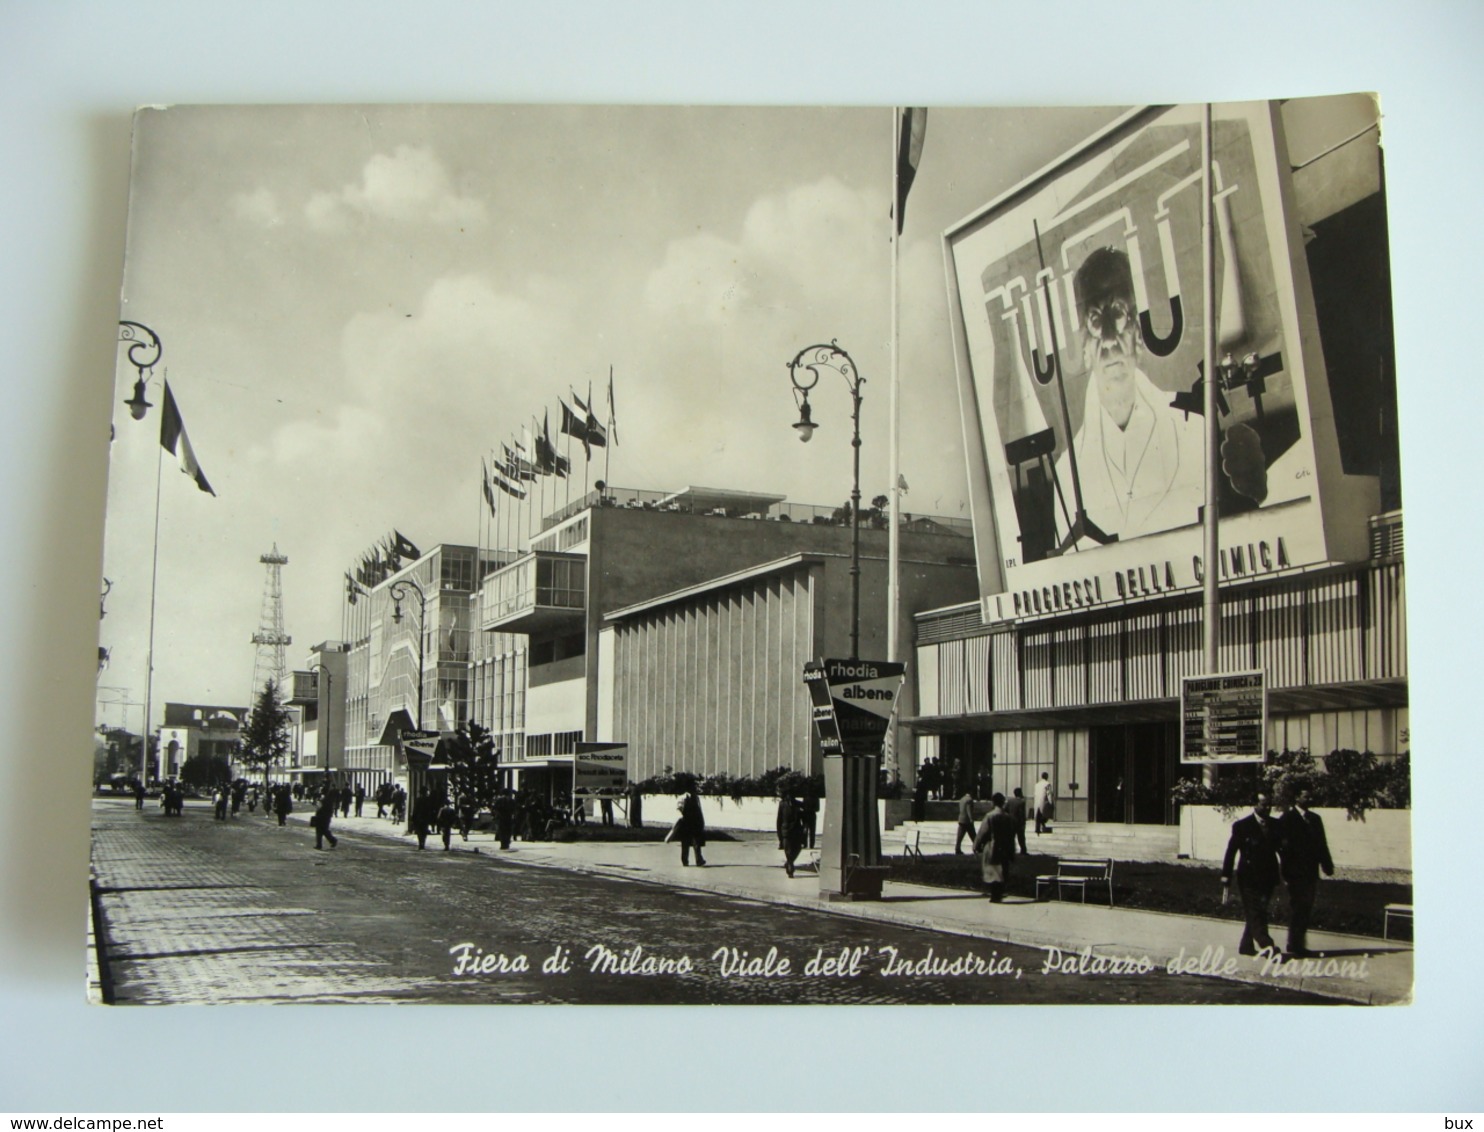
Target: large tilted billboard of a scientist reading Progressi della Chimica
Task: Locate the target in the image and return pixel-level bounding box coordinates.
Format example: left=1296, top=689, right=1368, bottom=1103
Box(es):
left=945, top=102, right=1359, bottom=620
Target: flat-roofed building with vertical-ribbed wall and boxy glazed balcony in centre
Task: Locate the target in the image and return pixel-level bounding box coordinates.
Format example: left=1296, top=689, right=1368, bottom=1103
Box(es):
left=472, top=487, right=975, bottom=786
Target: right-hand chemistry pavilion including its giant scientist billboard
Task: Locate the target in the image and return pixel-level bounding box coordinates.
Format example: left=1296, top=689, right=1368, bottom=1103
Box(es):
left=911, top=99, right=1410, bottom=823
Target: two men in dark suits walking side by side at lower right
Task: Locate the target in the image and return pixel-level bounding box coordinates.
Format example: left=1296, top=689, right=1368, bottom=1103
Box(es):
left=1221, top=789, right=1334, bottom=958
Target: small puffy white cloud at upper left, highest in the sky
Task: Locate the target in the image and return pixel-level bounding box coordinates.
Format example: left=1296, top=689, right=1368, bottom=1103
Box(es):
left=304, top=145, right=488, bottom=231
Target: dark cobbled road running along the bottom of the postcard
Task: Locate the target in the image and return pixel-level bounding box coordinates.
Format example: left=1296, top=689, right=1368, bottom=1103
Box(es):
left=93, top=798, right=1324, bottom=1004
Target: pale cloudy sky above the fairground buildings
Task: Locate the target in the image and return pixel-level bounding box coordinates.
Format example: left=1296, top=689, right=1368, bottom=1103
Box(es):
left=99, top=105, right=1120, bottom=727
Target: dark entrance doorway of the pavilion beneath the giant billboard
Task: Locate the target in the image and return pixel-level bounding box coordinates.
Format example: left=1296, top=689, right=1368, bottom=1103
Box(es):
left=1089, top=723, right=1180, bottom=825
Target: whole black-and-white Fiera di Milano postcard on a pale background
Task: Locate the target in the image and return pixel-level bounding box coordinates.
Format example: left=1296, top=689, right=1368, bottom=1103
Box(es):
left=89, top=92, right=1413, bottom=1018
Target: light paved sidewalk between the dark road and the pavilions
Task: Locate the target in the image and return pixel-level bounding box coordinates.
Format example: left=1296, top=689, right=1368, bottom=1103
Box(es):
left=307, top=813, right=1413, bottom=1004
